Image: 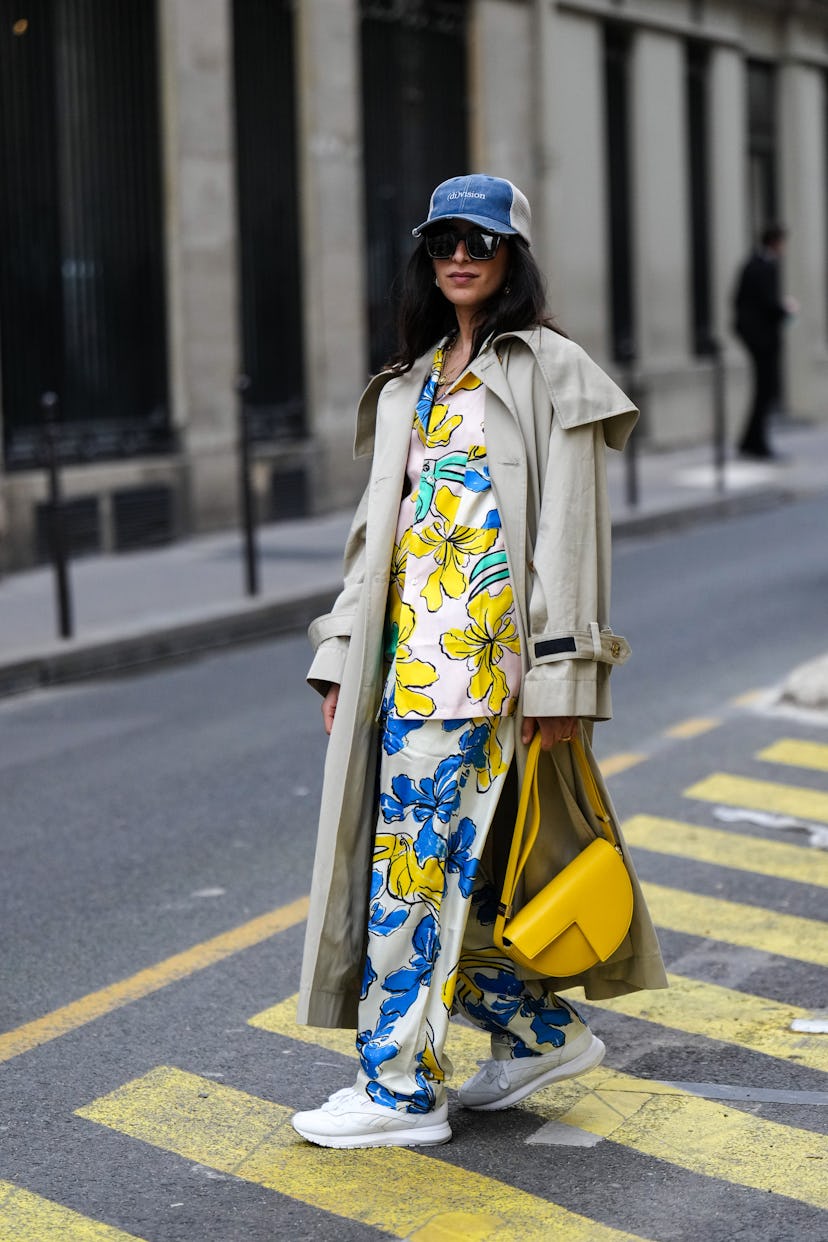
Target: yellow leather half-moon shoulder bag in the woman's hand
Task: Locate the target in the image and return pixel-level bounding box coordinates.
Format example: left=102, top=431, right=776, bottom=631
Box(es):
left=494, top=732, right=633, bottom=979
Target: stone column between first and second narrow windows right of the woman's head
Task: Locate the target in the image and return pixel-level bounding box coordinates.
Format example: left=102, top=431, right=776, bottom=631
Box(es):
left=631, top=30, right=708, bottom=441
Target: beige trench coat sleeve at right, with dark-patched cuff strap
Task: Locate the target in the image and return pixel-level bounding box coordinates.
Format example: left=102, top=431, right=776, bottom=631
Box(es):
left=523, top=419, right=629, bottom=720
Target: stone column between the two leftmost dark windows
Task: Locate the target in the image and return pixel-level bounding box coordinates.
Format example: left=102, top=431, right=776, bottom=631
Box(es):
left=159, top=0, right=240, bottom=529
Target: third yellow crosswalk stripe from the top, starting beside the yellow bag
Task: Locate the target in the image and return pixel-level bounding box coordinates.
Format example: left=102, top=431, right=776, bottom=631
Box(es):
left=623, top=815, right=828, bottom=888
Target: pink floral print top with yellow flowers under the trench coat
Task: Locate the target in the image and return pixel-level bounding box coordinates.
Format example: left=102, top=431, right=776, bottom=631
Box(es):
left=384, top=345, right=520, bottom=720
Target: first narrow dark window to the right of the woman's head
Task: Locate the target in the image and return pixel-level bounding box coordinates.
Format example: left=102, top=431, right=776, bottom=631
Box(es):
left=605, top=24, right=636, bottom=363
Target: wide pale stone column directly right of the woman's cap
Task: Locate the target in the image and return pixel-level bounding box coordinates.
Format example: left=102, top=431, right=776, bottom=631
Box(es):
left=472, top=0, right=608, bottom=356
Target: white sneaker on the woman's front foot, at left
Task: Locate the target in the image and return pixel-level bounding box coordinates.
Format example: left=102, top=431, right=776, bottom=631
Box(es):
left=292, top=1087, right=452, bottom=1148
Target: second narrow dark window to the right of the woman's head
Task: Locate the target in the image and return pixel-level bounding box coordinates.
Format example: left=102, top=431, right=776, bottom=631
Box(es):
left=686, top=42, right=713, bottom=354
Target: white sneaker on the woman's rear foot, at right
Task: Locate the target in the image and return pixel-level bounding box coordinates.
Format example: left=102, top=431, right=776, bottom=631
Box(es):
left=458, top=1030, right=607, bottom=1113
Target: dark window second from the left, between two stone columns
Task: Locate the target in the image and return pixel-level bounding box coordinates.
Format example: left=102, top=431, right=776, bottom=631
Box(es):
left=233, top=0, right=304, bottom=438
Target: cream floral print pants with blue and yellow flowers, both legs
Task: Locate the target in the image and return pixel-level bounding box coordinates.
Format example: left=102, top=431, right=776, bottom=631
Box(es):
left=356, top=715, right=583, bottom=1113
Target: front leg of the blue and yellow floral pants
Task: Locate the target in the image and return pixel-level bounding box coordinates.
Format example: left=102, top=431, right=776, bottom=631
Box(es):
left=356, top=715, right=514, bottom=1112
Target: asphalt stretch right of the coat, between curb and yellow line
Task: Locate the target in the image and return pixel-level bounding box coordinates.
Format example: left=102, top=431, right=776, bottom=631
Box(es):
left=597, top=493, right=828, bottom=751
